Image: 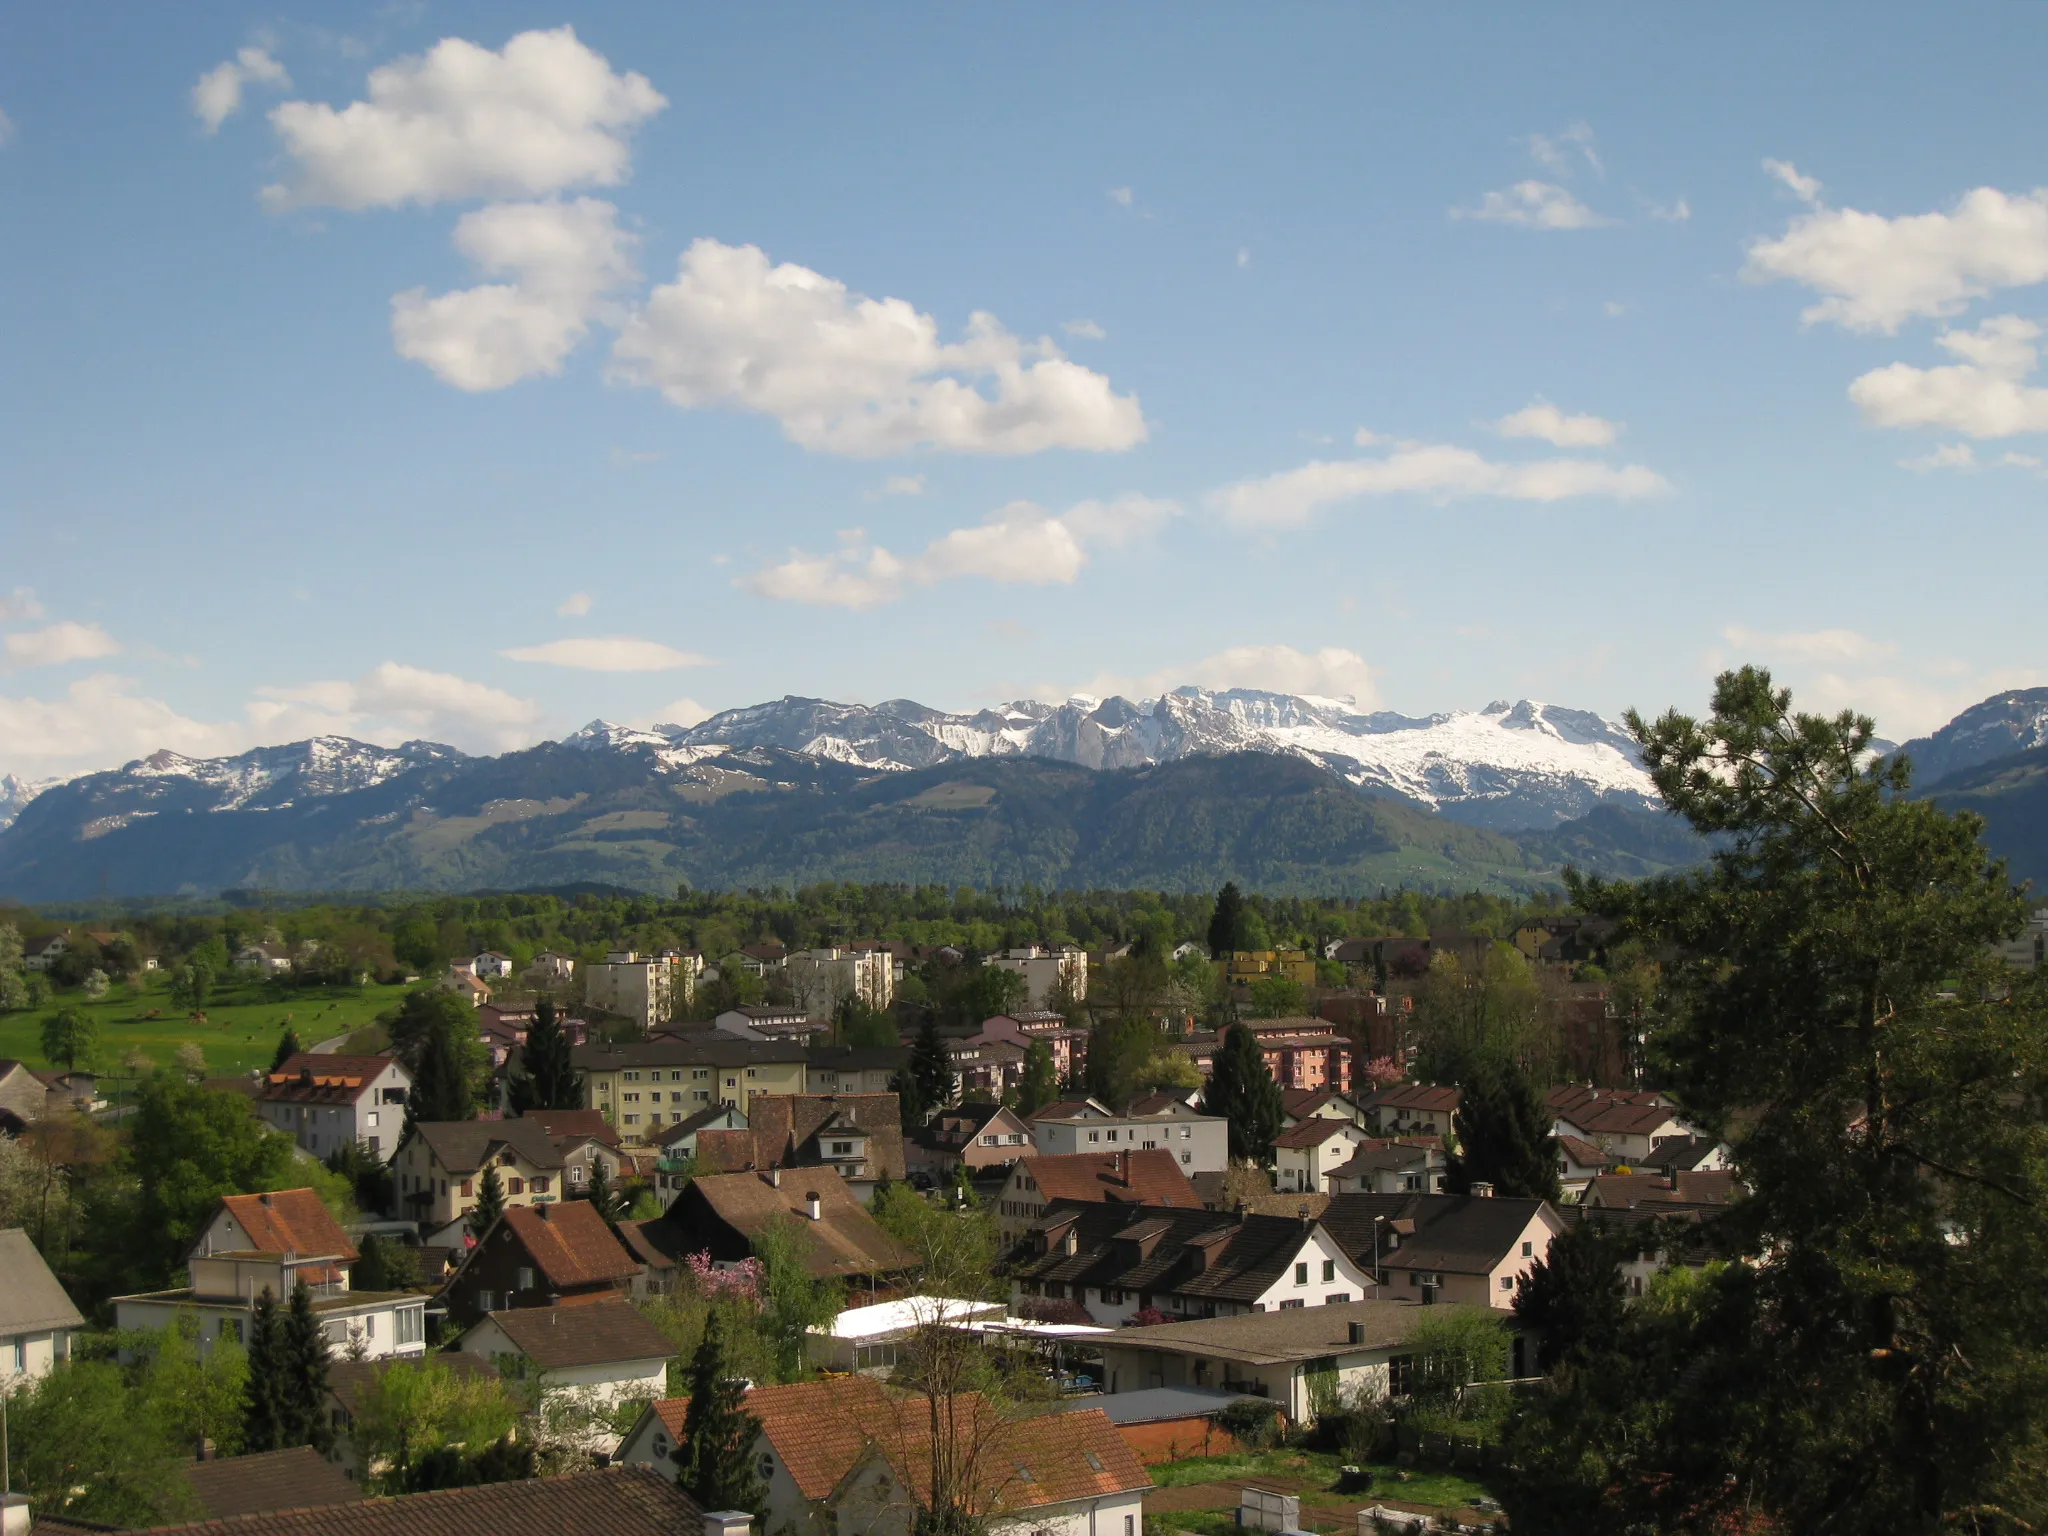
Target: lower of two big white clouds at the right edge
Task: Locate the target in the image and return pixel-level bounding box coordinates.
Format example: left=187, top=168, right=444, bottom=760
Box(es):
left=1849, top=315, right=2048, bottom=438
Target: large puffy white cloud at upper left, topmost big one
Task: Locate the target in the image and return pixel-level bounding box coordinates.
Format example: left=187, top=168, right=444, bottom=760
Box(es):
left=264, top=27, right=668, bottom=209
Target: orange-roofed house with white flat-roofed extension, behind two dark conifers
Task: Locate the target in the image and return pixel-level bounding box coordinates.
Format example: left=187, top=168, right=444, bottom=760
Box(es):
left=115, top=1190, right=426, bottom=1358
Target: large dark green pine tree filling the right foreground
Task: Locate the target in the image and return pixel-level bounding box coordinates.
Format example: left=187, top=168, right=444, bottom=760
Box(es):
left=1509, top=668, right=2048, bottom=1532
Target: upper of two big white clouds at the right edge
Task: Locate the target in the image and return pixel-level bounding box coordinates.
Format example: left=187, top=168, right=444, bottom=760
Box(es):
left=1743, top=177, right=2048, bottom=334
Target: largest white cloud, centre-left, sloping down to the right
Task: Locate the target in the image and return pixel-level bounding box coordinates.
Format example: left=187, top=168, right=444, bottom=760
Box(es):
left=612, top=240, right=1147, bottom=457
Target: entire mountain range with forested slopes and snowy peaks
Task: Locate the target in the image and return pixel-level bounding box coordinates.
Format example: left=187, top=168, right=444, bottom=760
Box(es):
left=0, top=688, right=2048, bottom=901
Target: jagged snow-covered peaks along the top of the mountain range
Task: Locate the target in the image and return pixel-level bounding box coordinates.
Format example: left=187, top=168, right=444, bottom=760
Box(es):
left=569, top=688, right=1655, bottom=829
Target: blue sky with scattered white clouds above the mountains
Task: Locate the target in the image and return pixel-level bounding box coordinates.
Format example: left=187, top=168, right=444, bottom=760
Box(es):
left=0, top=0, right=2048, bottom=778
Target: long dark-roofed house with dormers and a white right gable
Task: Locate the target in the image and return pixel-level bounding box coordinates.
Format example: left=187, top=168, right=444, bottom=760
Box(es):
left=1010, top=1200, right=1372, bottom=1327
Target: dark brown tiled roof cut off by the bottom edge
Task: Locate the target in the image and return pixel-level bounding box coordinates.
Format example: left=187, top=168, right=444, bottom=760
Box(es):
left=136, top=1466, right=705, bottom=1536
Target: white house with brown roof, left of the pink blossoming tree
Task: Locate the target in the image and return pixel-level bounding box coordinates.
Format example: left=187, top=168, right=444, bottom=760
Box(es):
left=455, top=1296, right=674, bottom=1407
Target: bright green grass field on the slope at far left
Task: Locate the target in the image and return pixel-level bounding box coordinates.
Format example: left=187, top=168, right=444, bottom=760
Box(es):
left=0, top=977, right=406, bottom=1077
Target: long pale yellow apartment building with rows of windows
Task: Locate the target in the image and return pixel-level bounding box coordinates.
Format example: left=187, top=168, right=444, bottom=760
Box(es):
left=569, top=1030, right=807, bottom=1145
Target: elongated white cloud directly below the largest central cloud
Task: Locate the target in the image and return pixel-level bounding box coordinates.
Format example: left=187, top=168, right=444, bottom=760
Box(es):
left=739, top=496, right=1180, bottom=608
